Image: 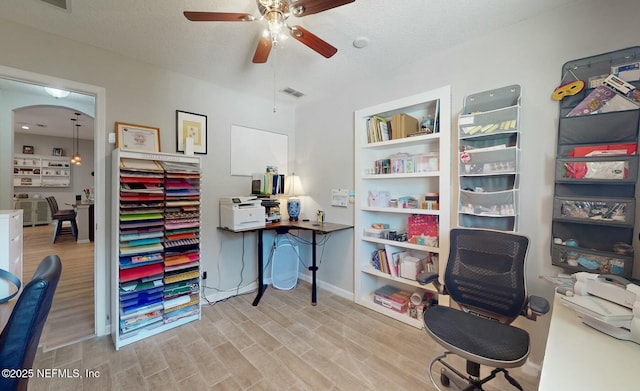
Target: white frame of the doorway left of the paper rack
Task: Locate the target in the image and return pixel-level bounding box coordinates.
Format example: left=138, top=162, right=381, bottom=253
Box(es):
left=0, top=65, right=111, bottom=336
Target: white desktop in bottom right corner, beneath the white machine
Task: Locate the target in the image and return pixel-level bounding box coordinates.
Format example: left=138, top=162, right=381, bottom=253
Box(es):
left=538, top=294, right=640, bottom=391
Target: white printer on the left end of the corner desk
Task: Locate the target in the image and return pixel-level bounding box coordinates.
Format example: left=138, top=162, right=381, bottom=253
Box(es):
left=220, top=196, right=265, bottom=231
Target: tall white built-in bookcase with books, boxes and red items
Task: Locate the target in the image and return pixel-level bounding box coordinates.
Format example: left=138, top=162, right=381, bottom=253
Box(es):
left=354, top=86, right=451, bottom=328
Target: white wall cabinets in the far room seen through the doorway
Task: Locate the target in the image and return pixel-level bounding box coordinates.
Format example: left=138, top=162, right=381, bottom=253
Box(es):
left=13, top=154, right=71, bottom=187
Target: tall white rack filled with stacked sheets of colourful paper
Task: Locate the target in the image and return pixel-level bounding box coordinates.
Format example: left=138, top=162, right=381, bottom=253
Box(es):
left=111, top=149, right=201, bottom=350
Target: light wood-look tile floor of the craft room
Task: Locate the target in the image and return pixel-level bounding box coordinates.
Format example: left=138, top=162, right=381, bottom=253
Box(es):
left=29, top=282, right=538, bottom=391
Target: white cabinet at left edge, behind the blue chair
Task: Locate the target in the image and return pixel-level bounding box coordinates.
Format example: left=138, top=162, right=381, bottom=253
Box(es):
left=0, top=210, right=23, bottom=297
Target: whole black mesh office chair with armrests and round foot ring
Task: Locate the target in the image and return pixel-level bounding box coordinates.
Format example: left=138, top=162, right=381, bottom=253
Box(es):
left=419, top=228, right=549, bottom=390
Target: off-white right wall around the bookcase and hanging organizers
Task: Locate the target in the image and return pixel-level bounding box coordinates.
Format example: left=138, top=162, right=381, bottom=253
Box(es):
left=296, top=0, right=640, bottom=364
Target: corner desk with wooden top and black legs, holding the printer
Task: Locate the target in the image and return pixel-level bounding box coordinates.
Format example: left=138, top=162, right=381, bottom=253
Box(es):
left=220, top=221, right=353, bottom=306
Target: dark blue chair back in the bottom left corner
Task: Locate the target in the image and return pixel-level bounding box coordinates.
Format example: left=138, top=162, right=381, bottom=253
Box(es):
left=0, top=255, right=62, bottom=391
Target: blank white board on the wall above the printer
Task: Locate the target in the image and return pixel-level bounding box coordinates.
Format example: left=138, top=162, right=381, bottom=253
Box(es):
left=231, top=125, right=289, bottom=175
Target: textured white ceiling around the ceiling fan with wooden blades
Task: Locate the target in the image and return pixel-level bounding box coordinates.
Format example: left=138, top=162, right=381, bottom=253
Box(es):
left=0, top=0, right=577, bottom=140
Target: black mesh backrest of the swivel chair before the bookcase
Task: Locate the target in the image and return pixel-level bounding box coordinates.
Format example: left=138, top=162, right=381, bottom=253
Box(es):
left=444, top=229, right=529, bottom=324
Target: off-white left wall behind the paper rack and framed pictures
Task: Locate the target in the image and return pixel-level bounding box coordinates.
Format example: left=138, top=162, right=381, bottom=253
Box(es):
left=0, top=20, right=295, bottom=334
